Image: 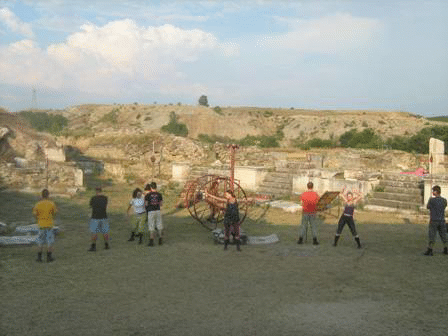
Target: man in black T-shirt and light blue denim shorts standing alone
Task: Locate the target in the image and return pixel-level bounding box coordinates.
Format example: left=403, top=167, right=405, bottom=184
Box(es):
left=89, top=187, right=109, bottom=252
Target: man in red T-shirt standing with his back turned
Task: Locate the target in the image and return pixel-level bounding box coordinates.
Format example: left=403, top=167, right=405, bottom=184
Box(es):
left=297, top=182, right=319, bottom=245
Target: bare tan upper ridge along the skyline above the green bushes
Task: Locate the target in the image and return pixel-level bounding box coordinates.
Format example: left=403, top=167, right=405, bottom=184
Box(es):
left=54, top=104, right=440, bottom=147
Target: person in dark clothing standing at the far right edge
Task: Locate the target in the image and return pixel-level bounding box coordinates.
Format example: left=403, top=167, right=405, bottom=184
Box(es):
left=424, top=186, right=448, bottom=256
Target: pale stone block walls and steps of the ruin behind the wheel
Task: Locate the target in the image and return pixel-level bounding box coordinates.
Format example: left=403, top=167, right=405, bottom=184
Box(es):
left=172, top=144, right=442, bottom=211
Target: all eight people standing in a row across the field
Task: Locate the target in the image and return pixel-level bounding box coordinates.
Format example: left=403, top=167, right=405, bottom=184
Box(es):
left=32, top=178, right=448, bottom=262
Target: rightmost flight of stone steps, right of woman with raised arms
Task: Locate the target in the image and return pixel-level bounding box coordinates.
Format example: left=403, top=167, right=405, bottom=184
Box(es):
left=368, top=173, right=423, bottom=211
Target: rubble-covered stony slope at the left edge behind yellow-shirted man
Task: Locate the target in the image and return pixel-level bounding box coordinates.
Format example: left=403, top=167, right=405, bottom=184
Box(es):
left=0, top=109, right=82, bottom=193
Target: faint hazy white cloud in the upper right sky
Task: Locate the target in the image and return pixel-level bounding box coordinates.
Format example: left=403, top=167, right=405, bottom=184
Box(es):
left=258, top=13, right=383, bottom=54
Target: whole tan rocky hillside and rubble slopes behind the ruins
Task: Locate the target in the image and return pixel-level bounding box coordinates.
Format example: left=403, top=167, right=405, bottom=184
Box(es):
left=0, top=104, right=440, bottom=190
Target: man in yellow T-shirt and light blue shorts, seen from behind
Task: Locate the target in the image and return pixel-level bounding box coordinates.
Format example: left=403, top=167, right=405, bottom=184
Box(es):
left=33, top=189, right=57, bottom=262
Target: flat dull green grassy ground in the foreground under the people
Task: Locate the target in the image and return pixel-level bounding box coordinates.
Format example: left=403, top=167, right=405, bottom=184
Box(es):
left=0, top=186, right=448, bottom=336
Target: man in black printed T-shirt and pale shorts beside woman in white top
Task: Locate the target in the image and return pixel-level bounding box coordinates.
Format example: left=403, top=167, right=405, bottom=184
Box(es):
left=145, top=182, right=163, bottom=246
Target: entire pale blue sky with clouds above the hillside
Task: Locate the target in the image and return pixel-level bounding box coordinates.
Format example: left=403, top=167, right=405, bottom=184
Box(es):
left=0, top=0, right=448, bottom=116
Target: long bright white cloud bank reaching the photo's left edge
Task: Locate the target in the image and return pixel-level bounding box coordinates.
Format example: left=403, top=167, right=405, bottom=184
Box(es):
left=0, top=19, right=238, bottom=93
